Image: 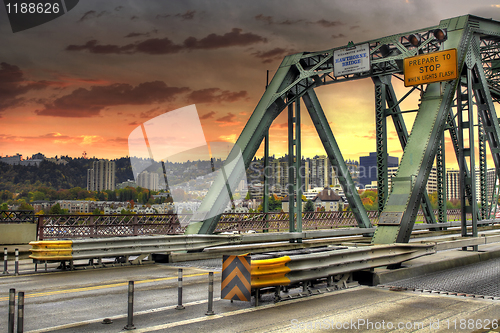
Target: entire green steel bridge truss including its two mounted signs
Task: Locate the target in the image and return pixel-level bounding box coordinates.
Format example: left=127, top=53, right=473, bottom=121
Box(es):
left=186, top=15, right=500, bottom=244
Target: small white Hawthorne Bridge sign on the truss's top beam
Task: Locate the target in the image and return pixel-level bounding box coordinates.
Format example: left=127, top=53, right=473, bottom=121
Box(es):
left=333, top=44, right=370, bottom=76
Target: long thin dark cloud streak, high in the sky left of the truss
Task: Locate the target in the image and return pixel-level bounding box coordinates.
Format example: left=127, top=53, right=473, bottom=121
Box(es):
left=66, top=28, right=267, bottom=54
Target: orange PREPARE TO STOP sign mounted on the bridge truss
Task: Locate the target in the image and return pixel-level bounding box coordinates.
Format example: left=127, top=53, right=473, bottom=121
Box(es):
left=404, top=49, right=458, bottom=87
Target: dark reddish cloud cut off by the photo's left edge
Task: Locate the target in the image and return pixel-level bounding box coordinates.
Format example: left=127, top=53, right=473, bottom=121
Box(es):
left=0, top=62, right=56, bottom=112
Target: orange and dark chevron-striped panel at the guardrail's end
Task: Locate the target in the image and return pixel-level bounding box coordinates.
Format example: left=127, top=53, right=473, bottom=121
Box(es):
left=221, top=254, right=252, bottom=302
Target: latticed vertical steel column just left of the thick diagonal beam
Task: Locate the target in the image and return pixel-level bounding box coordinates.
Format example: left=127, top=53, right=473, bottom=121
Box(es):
left=375, top=80, right=389, bottom=213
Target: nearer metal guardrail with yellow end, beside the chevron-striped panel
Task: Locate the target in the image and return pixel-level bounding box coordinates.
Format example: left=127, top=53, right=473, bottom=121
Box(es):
left=251, top=243, right=436, bottom=288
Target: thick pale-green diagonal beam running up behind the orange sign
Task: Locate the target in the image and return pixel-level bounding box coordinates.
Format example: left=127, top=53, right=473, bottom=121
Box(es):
left=372, top=21, right=470, bottom=244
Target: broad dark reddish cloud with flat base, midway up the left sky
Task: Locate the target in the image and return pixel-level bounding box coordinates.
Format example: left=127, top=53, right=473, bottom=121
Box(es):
left=35, top=81, right=190, bottom=117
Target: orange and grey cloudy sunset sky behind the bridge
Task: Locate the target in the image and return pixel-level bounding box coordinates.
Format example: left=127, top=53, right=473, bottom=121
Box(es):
left=0, top=0, right=500, bottom=169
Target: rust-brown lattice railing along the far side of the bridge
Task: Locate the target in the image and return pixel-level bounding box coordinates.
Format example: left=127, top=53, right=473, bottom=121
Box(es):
left=37, top=209, right=468, bottom=240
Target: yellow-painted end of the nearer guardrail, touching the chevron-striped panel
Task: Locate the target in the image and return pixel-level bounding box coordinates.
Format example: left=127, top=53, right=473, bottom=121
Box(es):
left=251, top=256, right=291, bottom=288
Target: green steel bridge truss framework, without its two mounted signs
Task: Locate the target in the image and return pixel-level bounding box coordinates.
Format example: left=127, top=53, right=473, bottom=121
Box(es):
left=186, top=15, right=500, bottom=244
